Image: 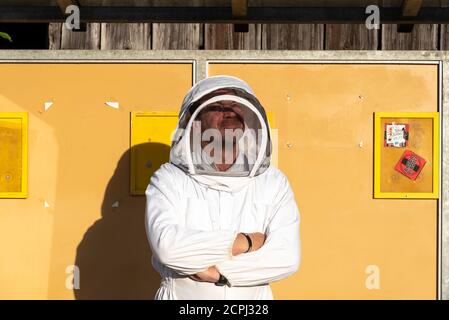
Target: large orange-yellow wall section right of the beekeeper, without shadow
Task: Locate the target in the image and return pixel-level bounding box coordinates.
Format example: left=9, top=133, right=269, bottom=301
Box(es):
left=209, top=62, right=438, bottom=299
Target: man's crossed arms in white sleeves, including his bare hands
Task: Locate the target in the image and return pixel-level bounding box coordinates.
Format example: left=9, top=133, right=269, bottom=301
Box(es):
left=145, top=167, right=300, bottom=286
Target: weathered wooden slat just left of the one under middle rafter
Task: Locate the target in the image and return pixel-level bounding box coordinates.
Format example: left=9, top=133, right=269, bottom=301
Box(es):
left=152, top=23, right=204, bottom=50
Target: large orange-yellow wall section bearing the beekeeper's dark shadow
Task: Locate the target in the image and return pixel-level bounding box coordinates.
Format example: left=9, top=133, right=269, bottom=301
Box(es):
left=0, top=63, right=192, bottom=299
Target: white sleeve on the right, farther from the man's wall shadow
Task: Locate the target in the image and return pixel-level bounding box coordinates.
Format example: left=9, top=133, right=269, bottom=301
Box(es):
left=216, top=178, right=301, bottom=286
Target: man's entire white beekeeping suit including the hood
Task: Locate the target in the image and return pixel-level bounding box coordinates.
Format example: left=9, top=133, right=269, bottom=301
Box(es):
left=145, top=76, right=300, bottom=300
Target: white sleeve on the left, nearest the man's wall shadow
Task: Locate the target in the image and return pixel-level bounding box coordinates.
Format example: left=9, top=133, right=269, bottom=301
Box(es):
left=145, top=166, right=237, bottom=275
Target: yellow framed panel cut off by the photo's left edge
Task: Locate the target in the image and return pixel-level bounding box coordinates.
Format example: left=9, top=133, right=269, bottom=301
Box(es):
left=0, top=112, right=28, bottom=198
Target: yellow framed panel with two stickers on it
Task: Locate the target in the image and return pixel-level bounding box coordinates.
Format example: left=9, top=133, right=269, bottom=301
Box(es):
left=374, top=112, right=439, bottom=199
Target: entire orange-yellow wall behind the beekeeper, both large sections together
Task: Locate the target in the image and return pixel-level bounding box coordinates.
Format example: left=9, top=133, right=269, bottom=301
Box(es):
left=0, top=64, right=438, bottom=299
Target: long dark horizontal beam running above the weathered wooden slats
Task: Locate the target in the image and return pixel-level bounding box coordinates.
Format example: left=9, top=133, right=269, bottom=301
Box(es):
left=0, top=5, right=449, bottom=24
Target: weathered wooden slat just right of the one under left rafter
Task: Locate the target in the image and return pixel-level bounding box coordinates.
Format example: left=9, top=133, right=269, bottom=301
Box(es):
left=100, top=23, right=151, bottom=50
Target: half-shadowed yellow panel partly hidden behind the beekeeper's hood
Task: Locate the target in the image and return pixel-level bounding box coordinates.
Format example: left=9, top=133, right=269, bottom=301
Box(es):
left=131, top=112, right=178, bottom=195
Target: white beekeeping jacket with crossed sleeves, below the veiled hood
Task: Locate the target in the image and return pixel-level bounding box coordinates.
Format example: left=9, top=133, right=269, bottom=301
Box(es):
left=145, top=77, right=300, bottom=300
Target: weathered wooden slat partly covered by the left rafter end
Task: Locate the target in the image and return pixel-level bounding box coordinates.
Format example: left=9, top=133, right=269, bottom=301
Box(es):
left=61, top=23, right=101, bottom=49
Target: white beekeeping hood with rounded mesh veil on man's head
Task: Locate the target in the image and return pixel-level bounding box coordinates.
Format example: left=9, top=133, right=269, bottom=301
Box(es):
left=170, top=75, right=272, bottom=192
